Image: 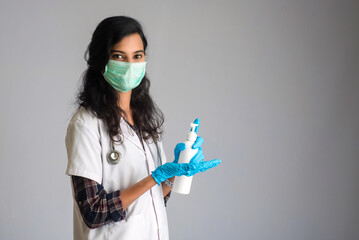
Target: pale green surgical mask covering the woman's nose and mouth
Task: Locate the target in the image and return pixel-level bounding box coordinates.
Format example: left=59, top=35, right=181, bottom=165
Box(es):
left=103, top=60, right=146, bottom=92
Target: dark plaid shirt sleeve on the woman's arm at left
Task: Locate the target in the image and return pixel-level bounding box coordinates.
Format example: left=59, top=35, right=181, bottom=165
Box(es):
left=72, top=176, right=126, bottom=228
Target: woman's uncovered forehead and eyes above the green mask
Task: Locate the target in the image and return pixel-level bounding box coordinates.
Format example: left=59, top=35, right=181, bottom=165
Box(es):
left=110, top=33, right=146, bottom=62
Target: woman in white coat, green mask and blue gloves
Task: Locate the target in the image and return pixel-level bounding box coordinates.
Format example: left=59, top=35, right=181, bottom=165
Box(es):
left=66, top=16, right=220, bottom=240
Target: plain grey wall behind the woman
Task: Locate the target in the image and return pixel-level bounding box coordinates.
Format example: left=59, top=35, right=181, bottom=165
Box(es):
left=0, top=0, right=359, bottom=240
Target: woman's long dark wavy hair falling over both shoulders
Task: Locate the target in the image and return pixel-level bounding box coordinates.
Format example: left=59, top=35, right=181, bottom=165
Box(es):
left=77, top=16, right=164, bottom=142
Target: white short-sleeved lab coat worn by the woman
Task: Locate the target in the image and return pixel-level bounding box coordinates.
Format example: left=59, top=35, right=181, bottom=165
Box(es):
left=66, top=107, right=169, bottom=240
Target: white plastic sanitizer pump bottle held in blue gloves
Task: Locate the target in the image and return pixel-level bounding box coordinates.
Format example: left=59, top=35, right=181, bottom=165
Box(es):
left=173, top=123, right=198, bottom=194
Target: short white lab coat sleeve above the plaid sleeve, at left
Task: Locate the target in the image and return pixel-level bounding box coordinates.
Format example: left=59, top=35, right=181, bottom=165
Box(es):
left=65, top=119, right=102, bottom=183
